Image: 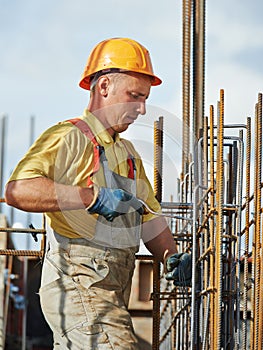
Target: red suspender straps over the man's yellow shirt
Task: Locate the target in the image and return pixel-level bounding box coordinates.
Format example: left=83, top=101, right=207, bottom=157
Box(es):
left=68, top=118, right=135, bottom=186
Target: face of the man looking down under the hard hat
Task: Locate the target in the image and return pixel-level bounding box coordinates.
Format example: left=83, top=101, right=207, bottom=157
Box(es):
left=100, top=73, right=151, bottom=136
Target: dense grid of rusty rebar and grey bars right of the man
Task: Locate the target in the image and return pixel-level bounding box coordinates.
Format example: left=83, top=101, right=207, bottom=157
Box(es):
left=157, top=90, right=263, bottom=350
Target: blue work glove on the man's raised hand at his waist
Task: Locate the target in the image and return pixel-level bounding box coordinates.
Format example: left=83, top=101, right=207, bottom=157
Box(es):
left=87, top=187, right=144, bottom=221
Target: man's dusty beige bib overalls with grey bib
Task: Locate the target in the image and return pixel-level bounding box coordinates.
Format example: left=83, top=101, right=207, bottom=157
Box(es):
left=39, top=119, right=141, bottom=350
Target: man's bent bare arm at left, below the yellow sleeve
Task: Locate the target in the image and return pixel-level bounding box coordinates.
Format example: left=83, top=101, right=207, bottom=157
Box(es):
left=5, top=177, right=94, bottom=212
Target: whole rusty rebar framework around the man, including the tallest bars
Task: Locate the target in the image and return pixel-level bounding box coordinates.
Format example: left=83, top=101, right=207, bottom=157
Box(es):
left=0, top=0, right=263, bottom=350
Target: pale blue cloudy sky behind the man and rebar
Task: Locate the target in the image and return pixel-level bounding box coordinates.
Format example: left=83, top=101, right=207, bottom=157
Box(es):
left=0, top=0, right=263, bottom=230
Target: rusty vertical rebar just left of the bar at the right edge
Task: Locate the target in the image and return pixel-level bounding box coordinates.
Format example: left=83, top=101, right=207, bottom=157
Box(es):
left=242, top=118, right=251, bottom=350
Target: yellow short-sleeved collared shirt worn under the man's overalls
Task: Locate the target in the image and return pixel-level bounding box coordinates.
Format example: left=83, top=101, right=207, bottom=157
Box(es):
left=9, top=110, right=160, bottom=239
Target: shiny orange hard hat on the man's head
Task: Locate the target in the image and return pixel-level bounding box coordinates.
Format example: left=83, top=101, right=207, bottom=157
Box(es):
left=79, top=38, right=162, bottom=90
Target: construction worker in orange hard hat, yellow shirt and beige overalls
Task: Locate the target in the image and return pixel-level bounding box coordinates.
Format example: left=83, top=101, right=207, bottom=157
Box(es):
left=6, top=38, right=191, bottom=350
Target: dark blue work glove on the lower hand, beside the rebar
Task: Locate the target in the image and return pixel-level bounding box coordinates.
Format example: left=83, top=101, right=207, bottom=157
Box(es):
left=165, top=253, right=192, bottom=287
